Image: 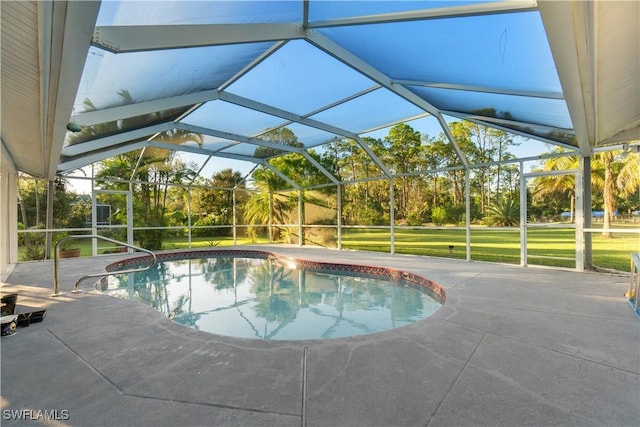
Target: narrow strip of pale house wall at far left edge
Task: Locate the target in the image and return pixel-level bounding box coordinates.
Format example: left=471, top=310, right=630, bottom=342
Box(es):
left=0, top=140, right=18, bottom=281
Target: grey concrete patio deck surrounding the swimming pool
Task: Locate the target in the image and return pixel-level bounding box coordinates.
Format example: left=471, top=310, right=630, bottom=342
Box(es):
left=0, top=245, right=640, bottom=427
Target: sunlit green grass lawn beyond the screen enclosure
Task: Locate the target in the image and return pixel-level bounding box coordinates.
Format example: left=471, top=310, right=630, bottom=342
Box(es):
left=19, top=223, right=640, bottom=271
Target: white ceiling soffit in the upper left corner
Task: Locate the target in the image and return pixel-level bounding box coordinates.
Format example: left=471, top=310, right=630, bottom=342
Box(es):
left=0, top=1, right=100, bottom=179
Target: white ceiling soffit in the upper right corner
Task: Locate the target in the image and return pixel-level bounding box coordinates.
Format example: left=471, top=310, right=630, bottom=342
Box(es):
left=539, top=1, right=640, bottom=155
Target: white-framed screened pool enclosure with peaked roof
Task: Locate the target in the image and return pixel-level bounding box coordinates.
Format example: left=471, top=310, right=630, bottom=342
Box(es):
left=0, top=0, right=640, bottom=274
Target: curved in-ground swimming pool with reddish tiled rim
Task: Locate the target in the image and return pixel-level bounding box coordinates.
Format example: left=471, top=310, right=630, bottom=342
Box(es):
left=100, top=250, right=444, bottom=340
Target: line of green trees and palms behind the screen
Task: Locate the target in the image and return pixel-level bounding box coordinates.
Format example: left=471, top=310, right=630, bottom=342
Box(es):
left=19, top=121, right=640, bottom=254
